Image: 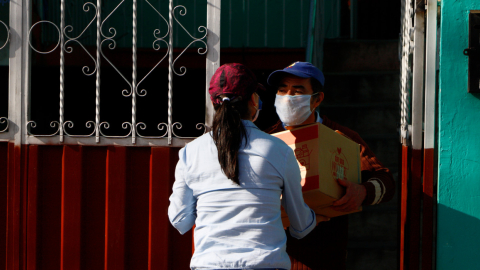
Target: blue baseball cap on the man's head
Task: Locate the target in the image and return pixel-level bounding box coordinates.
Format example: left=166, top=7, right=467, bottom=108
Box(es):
left=267, top=61, right=325, bottom=86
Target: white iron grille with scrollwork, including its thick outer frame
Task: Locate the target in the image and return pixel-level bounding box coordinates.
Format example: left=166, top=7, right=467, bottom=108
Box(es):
left=7, top=0, right=216, bottom=147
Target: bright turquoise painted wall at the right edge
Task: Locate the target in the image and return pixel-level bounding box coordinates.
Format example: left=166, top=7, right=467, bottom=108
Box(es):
left=437, top=0, right=480, bottom=270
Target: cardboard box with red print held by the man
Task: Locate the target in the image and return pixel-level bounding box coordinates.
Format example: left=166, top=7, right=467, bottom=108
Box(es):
left=272, top=123, right=361, bottom=227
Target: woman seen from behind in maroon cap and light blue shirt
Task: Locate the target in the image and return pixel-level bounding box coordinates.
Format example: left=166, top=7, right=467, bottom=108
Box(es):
left=168, top=64, right=325, bottom=270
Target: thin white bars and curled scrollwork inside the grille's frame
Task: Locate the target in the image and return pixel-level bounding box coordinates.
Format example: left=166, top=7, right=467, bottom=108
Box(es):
left=22, top=0, right=208, bottom=144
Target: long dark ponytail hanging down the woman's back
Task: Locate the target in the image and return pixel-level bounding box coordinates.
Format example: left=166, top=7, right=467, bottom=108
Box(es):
left=212, top=95, right=248, bottom=185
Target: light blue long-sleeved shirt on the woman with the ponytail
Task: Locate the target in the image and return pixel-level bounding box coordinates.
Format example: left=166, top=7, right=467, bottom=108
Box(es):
left=168, top=120, right=316, bottom=269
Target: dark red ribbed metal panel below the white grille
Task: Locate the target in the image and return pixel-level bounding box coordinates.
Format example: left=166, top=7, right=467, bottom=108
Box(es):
left=0, top=143, right=192, bottom=270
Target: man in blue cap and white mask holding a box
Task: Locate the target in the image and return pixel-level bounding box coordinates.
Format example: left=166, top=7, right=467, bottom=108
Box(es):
left=266, top=62, right=395, bottom=270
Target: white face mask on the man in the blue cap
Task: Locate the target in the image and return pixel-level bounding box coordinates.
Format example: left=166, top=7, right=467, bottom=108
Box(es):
left=275, top=95, right=315, bottom=126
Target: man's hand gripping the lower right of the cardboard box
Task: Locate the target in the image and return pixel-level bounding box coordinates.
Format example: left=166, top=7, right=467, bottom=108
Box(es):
left=331, top=179, right=367, bottom=212
